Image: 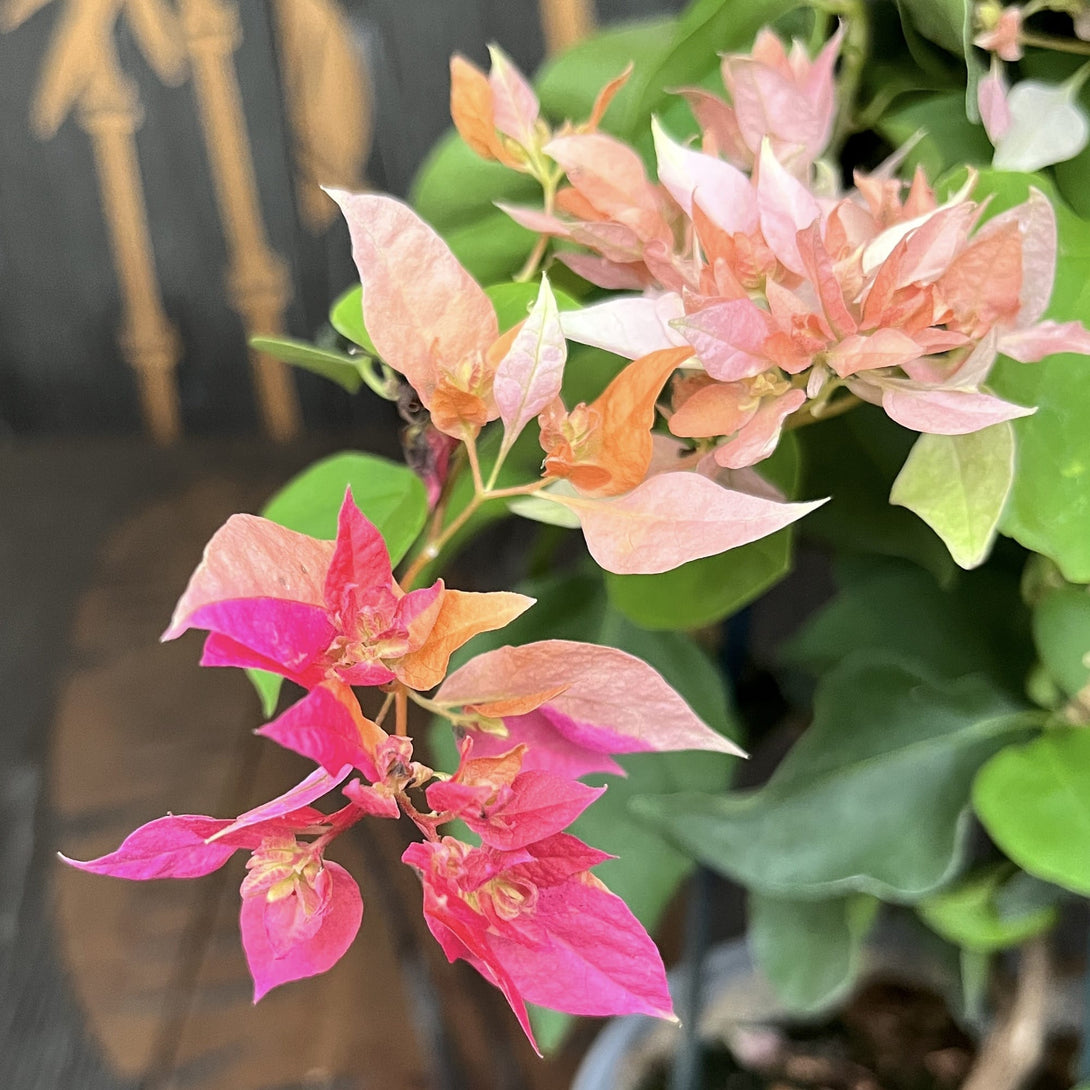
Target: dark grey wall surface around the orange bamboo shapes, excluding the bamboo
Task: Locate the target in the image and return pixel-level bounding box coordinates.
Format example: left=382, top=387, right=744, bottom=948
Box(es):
left=0, top=0, right=680, bottom=434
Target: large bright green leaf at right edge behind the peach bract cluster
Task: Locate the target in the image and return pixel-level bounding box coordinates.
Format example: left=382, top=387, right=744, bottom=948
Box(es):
left=974, top=171, right=1090, bottom=583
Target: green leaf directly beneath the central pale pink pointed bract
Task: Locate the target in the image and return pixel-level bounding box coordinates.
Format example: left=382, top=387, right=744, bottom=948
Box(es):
left=606, top=433, right=799, bottom=630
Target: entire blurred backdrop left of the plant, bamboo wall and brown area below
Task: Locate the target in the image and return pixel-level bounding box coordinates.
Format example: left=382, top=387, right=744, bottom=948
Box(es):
left=0, top=0, right=680, bottom=1090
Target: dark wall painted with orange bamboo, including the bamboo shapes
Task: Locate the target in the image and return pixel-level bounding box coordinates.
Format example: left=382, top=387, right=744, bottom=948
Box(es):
left=0, top=0, right=680, bottom=440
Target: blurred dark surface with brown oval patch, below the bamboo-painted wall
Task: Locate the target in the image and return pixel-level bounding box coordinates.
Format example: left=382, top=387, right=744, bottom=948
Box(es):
left=0, top=440, right=590, bottom=1090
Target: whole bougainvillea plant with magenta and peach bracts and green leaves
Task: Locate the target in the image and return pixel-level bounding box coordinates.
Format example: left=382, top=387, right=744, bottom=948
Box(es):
left=68, top=0, right=1090, bottom=1072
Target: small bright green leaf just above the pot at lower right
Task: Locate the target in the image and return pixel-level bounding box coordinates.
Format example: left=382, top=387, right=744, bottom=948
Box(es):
left=916, top=863, right=1058, bottom=953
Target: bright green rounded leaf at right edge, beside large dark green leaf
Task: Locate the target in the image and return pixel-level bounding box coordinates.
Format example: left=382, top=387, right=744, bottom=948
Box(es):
left=972, top=727, right=1090, bottom=896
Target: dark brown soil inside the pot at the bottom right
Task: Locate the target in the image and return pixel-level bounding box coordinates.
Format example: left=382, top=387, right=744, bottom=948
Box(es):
left=640, top=979, right=1075, bottom=1090
